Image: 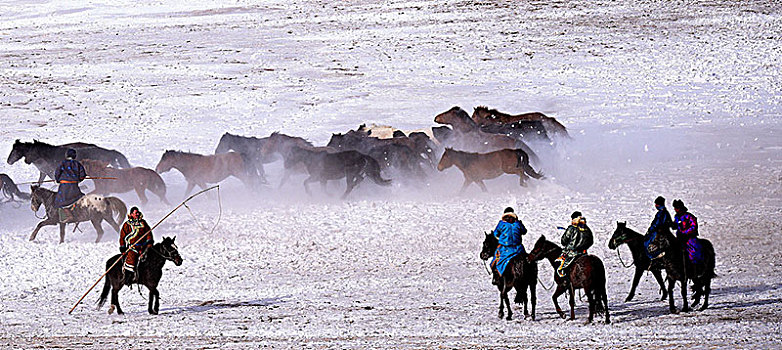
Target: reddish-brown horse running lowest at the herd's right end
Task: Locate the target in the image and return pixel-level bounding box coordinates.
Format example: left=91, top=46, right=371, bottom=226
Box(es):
left=437, top=148, right=543, bottom=192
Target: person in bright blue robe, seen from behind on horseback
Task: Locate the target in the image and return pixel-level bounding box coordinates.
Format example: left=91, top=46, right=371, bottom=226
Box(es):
left=491, top=207, right=527, bottom=285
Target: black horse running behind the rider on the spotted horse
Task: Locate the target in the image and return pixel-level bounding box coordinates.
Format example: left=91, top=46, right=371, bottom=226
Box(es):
left=8, top=140, right=130, bottom=184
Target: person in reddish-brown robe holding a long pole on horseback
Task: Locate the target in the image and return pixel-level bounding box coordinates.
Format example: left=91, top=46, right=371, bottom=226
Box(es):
left=119, top=207, right=153, bottom=285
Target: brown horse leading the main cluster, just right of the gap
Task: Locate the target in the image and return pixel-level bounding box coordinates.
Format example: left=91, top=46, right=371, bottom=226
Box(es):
left=155, top=151, right=256, bottom=197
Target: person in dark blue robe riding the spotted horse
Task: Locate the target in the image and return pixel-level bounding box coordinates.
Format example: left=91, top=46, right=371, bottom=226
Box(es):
left=54, top=148, right=87, bottom=222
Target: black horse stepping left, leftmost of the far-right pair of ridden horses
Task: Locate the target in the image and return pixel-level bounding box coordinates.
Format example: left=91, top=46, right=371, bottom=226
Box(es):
left=608, top=222, right=668, bottom=302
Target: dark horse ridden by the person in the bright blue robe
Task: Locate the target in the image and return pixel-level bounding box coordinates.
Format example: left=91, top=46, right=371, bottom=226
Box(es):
left=480, top=233, right=538, bottom=320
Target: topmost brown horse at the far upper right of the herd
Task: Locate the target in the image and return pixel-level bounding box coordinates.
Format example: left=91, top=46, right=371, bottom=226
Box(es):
left=472, top=106, right=570, bottom=138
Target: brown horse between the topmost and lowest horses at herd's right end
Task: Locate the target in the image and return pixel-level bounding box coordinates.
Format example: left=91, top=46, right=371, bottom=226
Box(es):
left=433, top=107, right=540, bottom=163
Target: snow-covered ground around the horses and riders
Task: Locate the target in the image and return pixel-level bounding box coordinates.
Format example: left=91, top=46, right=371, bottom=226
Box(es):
left=0, top=0, right=782, bottom=349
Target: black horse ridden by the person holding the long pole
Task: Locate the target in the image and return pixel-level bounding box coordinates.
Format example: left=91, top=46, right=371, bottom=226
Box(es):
left=98, top=237, right=182, bottom=315
